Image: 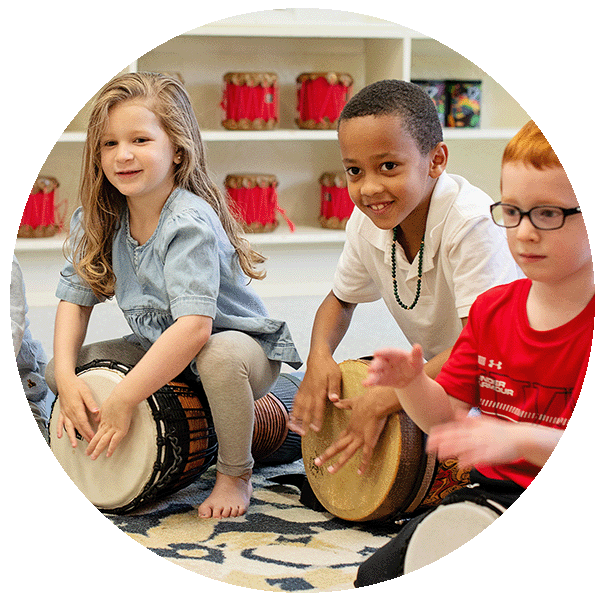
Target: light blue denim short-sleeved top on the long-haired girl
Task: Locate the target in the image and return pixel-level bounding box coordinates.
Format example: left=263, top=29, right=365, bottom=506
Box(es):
left=56, top=188, right=302, bottom=369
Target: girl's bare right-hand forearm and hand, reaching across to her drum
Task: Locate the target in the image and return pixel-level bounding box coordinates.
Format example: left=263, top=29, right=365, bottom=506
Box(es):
left=86, top=315, right=212, bottom=459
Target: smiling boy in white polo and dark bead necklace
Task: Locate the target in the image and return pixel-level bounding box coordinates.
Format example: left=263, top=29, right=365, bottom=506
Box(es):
left=290, top=80, right=518, bottom=472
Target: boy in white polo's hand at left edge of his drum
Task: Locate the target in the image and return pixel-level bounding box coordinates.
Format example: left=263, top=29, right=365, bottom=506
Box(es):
left=289, top=356, right=342, bottom=435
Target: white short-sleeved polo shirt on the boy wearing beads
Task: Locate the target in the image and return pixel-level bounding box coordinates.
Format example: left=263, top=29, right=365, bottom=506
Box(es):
left=333, top=173, right=522, bottom=360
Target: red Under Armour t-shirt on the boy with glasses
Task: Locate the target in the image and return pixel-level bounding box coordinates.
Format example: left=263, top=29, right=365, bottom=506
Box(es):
left=437, top=279, right=594, bottom=487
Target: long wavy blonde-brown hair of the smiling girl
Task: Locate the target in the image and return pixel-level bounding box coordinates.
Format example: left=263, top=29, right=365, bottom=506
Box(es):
left=67, top=73, right=265, bottom=298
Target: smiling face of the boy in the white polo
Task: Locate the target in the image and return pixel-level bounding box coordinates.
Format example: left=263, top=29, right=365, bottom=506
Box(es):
left=339, top=115, right=447, bottom=232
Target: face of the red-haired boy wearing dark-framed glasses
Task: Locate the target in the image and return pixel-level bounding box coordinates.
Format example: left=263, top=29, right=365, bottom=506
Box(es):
left=502, top=162, right=592, bottom=285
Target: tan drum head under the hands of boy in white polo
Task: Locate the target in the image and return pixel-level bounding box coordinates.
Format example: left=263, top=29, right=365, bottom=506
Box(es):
left=302, top=361, right=422, bottom=521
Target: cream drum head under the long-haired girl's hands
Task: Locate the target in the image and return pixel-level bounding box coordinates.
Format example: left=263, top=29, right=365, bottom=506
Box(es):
left=50, top=367, right=157, bottom=510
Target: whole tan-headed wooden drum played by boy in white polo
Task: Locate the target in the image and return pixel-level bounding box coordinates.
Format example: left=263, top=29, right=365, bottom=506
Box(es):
left=302, top=360, right=470, bottom=521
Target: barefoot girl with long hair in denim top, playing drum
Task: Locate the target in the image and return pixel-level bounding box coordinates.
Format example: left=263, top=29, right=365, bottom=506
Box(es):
left=46, top=73, right=301, bottom=518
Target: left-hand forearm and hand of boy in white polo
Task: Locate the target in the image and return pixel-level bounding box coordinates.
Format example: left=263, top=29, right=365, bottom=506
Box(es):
left=290, top=292, right=356, bottom=435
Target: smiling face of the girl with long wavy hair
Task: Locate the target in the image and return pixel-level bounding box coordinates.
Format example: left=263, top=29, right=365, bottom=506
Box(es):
left=100, top=100, right=180, bottom=204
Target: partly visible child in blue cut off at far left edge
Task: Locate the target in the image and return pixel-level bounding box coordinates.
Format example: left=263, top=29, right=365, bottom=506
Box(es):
left=10, top=254, right=48, bottom=442
